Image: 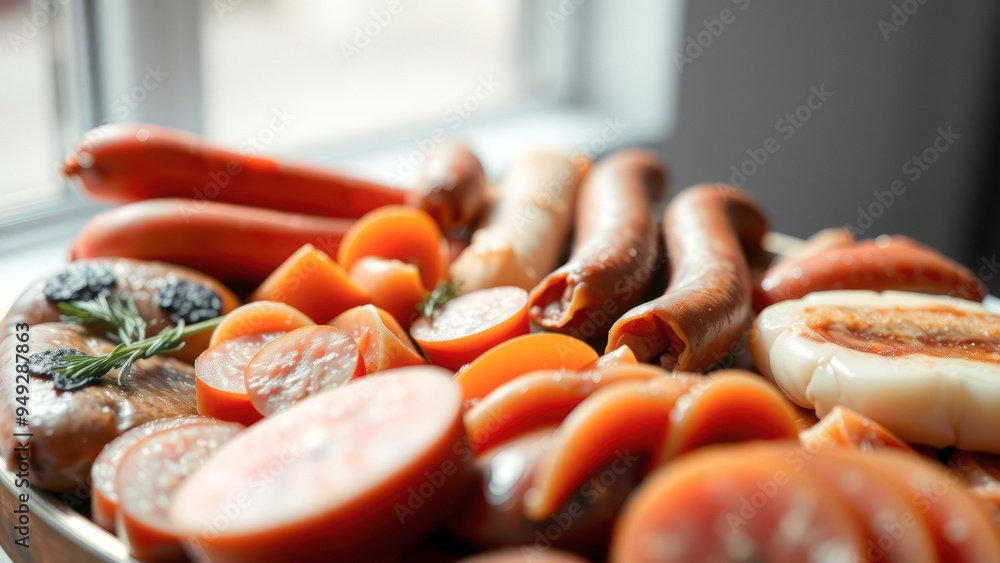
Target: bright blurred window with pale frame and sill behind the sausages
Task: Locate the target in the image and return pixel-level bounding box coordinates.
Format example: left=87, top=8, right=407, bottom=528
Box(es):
left=0, top=0, right=683, bottom=219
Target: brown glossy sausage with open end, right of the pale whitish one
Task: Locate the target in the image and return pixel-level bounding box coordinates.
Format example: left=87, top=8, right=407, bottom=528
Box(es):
left=530, top=150, right=666, bottom=338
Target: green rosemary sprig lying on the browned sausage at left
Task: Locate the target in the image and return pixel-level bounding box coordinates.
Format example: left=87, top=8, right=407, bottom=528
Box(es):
left=53, top=316, right=225, bottom=385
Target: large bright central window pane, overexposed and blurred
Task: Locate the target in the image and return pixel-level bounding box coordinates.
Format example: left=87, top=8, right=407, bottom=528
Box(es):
left=201, top=0, right=529, bottom=153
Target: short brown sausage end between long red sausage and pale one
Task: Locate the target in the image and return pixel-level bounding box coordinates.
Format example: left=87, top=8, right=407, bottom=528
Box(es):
left=406, top=143, right=489, bottom=233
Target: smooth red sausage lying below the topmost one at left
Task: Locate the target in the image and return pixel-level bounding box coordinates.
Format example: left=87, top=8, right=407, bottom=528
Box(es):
left=72, top=199, right=352, bottom=286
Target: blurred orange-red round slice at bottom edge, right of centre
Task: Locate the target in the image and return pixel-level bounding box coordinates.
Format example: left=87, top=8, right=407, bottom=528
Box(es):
left=609, top=445, right=866, bottom=563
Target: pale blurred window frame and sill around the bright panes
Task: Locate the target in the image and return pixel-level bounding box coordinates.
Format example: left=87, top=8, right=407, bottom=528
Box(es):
left=0, top=0, right=683, bottom=236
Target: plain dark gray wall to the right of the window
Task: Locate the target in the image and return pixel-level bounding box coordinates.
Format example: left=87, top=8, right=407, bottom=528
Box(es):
left=658, top=0, right=1000, bottom=294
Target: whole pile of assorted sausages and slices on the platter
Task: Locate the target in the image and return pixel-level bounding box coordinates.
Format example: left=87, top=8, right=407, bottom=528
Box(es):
left=0, top=126, right=1000, bottom=563
